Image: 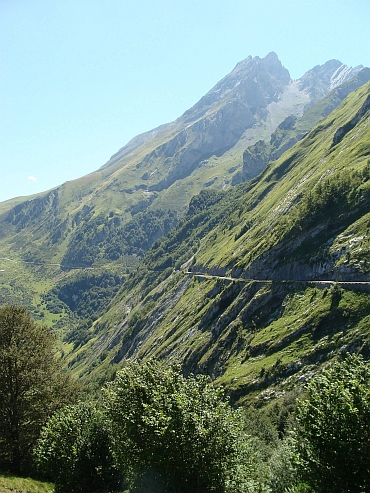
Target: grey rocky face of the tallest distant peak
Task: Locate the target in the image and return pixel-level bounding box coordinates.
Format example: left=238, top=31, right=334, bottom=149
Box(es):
left=111, top=53, right=296, bottom=191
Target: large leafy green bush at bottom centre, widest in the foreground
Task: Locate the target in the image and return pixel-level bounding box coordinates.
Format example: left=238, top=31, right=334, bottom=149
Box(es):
left=105, top=361, right=251, bottom=493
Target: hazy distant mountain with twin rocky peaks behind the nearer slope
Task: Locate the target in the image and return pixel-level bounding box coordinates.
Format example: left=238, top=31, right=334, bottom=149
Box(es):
left=0, top=53, right=360, bottom=338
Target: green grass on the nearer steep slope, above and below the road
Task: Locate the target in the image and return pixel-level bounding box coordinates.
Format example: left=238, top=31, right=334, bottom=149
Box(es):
left=50, top=80, right=370, bottom=403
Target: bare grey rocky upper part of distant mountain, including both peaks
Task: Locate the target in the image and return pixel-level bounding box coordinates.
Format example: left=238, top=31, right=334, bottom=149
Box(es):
left=100, top=52, right=361, bottom=195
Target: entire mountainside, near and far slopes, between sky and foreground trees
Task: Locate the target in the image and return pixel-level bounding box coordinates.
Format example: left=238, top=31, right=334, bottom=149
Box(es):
left=0, top=53, right=370, bottom=402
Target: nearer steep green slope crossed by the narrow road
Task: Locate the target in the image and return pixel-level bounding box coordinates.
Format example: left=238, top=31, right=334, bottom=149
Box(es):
left=67, top=83, right=370, bottom=401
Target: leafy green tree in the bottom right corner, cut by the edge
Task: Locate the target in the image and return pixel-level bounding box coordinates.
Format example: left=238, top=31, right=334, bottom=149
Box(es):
left=296, top=355, right=370, bottom=493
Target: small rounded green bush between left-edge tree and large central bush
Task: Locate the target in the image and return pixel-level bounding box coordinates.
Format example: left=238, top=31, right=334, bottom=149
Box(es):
left=34, top=403, right=121, bottom=493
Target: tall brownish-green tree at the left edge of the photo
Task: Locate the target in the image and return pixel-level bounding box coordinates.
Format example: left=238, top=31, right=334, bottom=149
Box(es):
left=0, top=305, right=78, bottom=472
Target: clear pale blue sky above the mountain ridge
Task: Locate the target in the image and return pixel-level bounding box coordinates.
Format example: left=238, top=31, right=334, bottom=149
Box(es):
left=0, top=0, right=370, bottom=201
